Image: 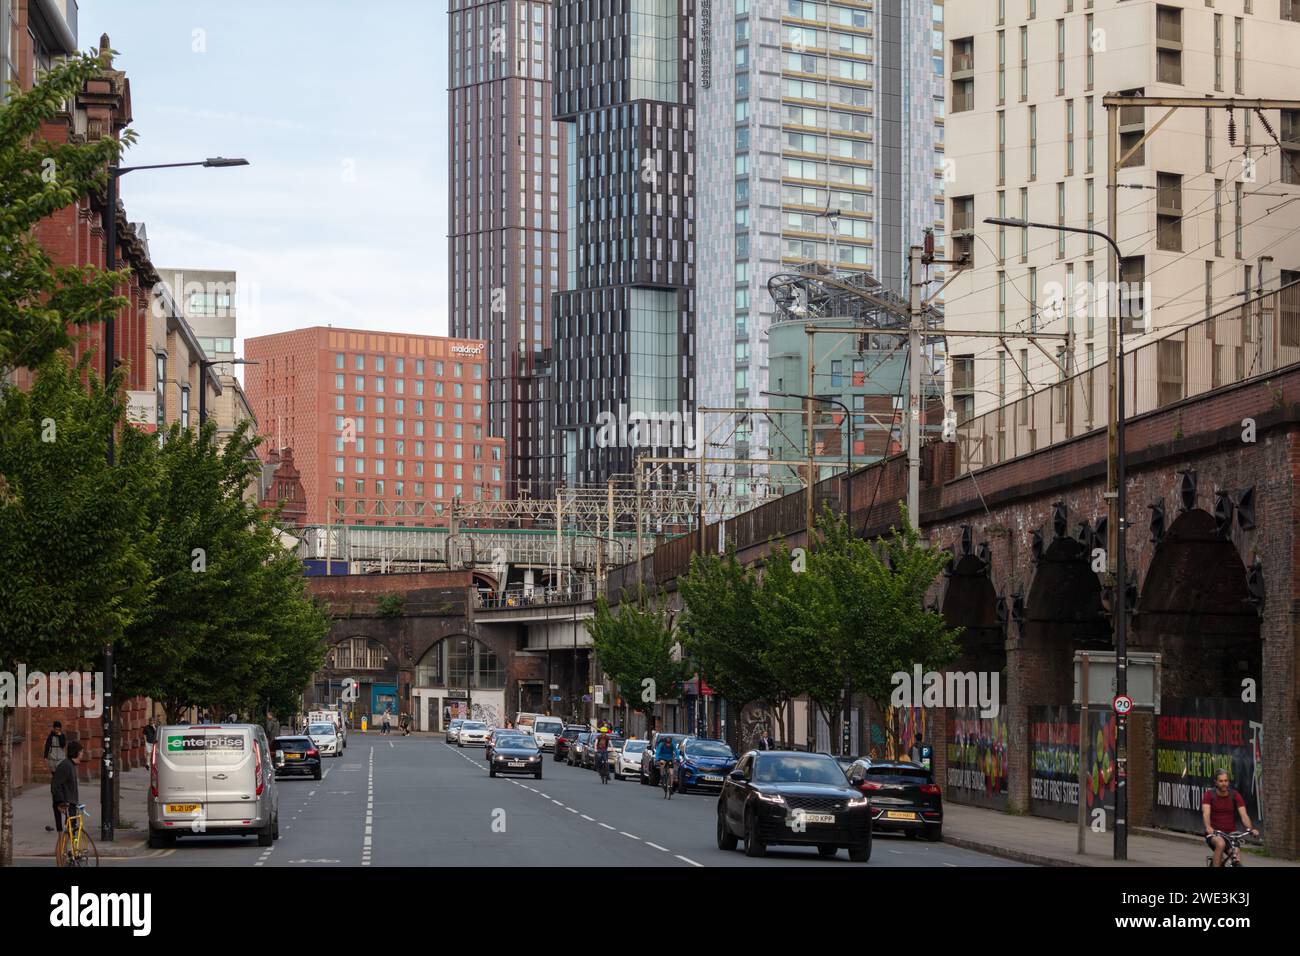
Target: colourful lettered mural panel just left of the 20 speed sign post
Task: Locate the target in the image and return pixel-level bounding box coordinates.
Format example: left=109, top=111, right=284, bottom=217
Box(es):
left=1030, top=705, right=1117, bottom=832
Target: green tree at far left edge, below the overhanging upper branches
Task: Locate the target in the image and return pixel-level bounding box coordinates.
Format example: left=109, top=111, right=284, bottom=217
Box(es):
left=0, top=356, right=153, bottom=865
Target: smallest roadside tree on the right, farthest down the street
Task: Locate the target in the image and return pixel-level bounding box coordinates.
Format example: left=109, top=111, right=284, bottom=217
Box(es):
left=586, top=587, right=689, bottom=714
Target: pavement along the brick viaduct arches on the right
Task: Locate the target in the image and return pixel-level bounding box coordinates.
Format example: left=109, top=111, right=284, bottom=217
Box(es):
left=944, top=801, right=1300, bottom=868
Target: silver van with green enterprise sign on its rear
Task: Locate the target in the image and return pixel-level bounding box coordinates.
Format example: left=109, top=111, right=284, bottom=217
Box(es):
left=148, top=723, right=280, bottom=848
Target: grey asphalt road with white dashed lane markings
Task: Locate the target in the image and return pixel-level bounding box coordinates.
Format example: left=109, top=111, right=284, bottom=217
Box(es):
left=71, top=734, right=1017, bottom=868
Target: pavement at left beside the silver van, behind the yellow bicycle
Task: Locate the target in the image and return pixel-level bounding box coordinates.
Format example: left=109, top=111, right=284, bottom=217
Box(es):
left=13, top=770, right=151, bottom=862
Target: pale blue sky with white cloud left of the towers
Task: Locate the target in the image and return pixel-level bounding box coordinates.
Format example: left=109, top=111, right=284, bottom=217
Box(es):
left=78, top=0, right=447, bottom=356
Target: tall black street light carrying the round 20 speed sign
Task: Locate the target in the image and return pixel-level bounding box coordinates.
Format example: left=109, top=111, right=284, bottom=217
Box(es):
left=984, top=217, right=1128, bottom=860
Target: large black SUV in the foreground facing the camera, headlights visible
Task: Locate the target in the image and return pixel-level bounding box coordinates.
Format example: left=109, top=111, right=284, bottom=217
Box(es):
left=718, top=750, right=871, bottom=864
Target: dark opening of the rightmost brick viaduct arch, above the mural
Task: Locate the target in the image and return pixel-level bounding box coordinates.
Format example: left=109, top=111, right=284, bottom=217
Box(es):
left=1130, top=509, right=1264, bottom=697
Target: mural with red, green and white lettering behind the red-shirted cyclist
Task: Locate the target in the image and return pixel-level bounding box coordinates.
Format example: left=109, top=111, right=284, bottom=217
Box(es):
left=1154, top=697, right=1264, bottom=834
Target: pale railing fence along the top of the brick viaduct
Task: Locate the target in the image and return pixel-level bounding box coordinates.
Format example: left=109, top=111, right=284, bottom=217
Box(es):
left=957, top=282, right=1300, bottom=475
